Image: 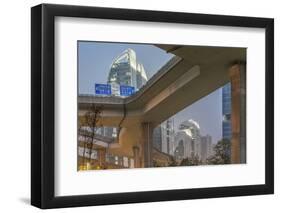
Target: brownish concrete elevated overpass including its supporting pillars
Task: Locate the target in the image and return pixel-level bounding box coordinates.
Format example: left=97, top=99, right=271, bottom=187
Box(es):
left=78, top=45, right=246, bottom=167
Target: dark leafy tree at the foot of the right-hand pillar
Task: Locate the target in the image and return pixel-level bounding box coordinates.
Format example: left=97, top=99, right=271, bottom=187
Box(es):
left=207, top=139, right=230, bottom=164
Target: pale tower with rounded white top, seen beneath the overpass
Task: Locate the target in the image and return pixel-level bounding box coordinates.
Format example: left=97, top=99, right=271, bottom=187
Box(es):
left=175, top=119, right=201, bottom=159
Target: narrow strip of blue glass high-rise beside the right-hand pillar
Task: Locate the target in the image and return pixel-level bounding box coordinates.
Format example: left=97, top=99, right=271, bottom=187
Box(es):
left=222, top=83, right=232, bottom=140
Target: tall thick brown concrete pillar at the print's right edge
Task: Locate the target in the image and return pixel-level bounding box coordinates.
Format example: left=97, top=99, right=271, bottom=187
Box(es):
left=229, top=63, right=246, bottom=163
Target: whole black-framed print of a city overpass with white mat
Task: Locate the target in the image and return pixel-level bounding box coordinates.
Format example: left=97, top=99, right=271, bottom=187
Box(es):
left=31, top=4, right=274, bottom=208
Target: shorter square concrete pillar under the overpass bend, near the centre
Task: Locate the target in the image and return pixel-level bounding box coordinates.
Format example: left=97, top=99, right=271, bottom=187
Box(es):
left=141, top=123, right=153, bottom=167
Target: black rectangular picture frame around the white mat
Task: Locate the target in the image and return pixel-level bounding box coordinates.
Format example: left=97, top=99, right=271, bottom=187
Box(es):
left=31, top=4, right=274, bottom=209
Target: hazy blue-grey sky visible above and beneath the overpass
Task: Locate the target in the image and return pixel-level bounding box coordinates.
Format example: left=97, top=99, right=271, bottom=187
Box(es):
left=78, top=41, right=222, bottom=143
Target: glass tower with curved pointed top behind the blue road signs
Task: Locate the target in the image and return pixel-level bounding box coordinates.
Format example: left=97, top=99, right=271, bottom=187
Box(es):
left=107, top=49, right=147, bottom=91
